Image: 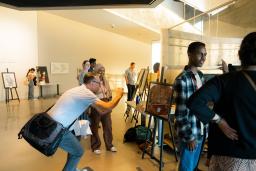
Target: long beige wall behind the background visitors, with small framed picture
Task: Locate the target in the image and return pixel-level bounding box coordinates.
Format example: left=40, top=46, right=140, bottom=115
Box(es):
left=38, top=12, right=151, bottom=92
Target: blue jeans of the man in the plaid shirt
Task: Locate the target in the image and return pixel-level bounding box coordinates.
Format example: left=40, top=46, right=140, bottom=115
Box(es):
left=178, top=139, right=203, bottom=171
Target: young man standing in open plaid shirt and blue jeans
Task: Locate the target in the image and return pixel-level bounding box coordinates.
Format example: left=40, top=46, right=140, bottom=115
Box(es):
left=174, top=42, right=207, bottom=171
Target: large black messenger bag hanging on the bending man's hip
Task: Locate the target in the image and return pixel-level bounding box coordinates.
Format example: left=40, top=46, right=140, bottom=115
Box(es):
left=18, top=112, right=74, bottom=156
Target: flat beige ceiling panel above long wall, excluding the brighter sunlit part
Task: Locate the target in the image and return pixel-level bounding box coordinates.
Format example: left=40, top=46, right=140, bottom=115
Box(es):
left=44, top=9, right=160, bottom=43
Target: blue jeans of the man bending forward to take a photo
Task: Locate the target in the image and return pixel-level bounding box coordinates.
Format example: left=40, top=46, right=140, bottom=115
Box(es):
left=59, top=131, right=84, bottom=171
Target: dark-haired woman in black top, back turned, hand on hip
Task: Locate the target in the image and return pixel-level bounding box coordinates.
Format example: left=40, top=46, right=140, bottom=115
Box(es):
left=187, top=32, right=256, bottom=171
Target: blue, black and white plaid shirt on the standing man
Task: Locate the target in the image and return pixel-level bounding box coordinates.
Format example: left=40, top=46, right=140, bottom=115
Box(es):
left=174, top=66, right=207, bottom=142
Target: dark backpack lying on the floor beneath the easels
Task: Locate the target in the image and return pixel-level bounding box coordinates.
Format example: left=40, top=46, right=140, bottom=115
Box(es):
left=124, top=125, right=152, bottom=144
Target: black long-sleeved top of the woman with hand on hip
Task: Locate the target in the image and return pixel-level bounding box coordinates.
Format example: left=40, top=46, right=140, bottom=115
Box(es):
left=187, top=71, right=256, bottom=159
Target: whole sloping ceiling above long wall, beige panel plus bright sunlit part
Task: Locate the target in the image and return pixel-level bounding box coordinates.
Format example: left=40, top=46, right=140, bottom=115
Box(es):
left=44, top=0, right=183, bottom=43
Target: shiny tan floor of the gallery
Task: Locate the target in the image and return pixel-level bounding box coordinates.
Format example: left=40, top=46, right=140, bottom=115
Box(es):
left=0, top=97, right=207, bottom=171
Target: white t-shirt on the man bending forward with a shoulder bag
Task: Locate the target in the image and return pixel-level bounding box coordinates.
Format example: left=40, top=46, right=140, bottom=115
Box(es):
left=47, top=84, right=99, bottom=127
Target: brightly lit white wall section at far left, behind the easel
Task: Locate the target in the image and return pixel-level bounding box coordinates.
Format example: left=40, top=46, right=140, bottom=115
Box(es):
left=0, top=7, right=38, bottom=100
